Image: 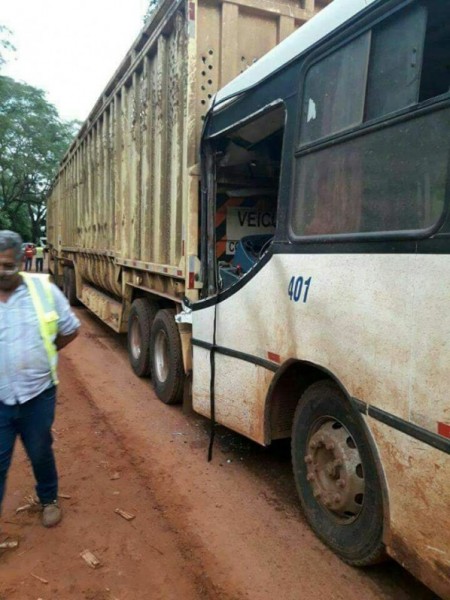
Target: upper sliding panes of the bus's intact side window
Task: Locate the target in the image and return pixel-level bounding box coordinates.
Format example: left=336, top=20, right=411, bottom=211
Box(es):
left=300, top=0, right=450, bottom=138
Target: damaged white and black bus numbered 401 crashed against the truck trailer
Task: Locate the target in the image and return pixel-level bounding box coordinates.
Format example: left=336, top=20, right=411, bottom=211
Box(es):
left=188, top=0, right=450, bottom=598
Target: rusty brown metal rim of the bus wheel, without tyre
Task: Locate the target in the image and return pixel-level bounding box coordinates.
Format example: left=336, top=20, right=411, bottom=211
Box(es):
left=305, top=417, right=365, bottom=523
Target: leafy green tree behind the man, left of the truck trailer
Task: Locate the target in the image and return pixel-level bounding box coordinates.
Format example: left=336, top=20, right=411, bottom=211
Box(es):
left=0, top=76, right=79, bottom=242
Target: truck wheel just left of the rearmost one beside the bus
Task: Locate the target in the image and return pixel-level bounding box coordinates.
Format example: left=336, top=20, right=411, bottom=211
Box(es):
left=127, top=298, right=158, bottom=377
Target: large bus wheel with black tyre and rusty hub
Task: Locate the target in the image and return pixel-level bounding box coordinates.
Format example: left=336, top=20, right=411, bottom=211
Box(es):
left=292, top=380, right=385, bottom=566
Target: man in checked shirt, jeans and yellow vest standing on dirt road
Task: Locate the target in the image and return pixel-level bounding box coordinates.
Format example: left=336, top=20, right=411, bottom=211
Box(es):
left=0, top=231, right=80, bottom=548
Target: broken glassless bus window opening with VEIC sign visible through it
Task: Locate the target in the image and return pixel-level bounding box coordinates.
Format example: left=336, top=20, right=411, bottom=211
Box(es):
left=213, top=106, right=285, bottom=290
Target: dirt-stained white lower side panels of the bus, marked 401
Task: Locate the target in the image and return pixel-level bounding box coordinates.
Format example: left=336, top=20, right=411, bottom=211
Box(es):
left=193, top=253, right=450, bottom=585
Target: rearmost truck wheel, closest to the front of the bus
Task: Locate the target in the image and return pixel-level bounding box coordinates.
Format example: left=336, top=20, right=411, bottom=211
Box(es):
left=150, top=309, right=185, bottom=404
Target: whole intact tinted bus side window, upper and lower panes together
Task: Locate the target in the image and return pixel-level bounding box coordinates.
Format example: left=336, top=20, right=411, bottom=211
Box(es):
left=292, top=0, right=450, bottom=236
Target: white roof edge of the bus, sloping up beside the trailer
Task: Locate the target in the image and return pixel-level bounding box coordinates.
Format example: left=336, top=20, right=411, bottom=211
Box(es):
left=215, top=0, right=376, bottom=108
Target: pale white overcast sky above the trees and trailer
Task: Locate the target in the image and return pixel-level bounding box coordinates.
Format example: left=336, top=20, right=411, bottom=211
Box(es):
left=0, top=0, right=148, bottom=121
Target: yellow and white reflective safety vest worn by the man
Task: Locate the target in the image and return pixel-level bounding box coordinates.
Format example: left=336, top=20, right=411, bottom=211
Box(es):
left=21, top=273, right=59, bottom=385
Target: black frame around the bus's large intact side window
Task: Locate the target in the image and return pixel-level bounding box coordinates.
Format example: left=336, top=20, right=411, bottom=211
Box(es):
left=286, top=0, right=450, bottom=244
